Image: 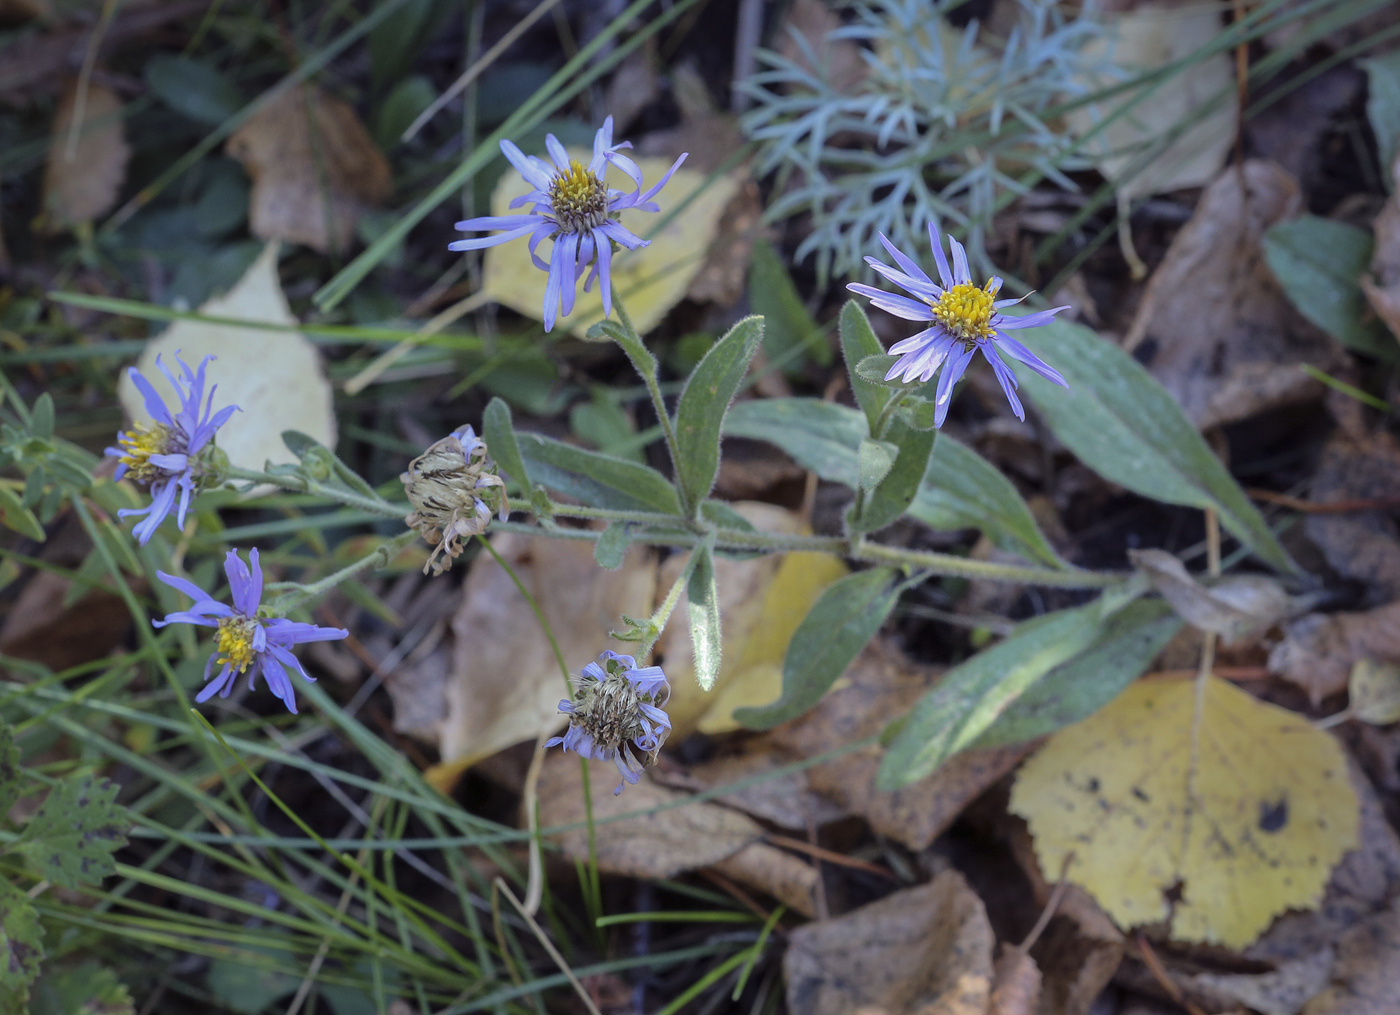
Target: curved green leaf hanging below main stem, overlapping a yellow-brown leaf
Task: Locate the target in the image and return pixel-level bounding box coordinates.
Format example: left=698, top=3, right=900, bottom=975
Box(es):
left=734, top=567, right=899, bottom=729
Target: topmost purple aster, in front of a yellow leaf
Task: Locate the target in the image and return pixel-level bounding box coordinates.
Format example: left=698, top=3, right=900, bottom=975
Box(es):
left=448, top=116, right=686, bottom=332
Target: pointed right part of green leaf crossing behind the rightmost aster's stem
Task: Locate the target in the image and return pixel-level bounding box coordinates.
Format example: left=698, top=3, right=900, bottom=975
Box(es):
left=909, top=434, right=1068, bottom=567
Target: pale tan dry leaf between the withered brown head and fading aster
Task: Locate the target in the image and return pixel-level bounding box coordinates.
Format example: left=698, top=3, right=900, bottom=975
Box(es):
left=441, top=532, right=657, bottom=767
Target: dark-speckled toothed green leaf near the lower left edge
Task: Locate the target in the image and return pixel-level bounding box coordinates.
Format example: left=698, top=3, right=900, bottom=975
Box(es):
left=10, top=776, right=130, bottom=888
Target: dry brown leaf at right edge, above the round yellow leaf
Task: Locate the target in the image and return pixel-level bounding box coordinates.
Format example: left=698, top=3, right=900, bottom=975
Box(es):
left=1268, top=602, right=1400, bottom=706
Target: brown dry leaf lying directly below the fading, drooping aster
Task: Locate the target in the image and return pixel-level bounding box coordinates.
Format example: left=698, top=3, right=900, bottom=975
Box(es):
left=539, top=752, right=819, bottom=917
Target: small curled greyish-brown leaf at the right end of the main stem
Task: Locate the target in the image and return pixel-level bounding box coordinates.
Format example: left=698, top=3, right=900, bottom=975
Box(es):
left=1128, top=550, right=1292, bottom=645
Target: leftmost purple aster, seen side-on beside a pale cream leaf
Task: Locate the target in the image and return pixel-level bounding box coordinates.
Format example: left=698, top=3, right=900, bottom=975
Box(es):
left=104, top=353, right=238, bottom=546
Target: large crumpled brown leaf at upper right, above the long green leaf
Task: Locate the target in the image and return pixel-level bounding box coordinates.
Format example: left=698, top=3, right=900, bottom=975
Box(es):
left=1127, top=160, right=1338, bottom=430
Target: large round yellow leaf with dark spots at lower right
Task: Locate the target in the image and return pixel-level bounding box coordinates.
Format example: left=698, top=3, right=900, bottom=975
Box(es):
left=1011, top=678, right=1359, bottom=949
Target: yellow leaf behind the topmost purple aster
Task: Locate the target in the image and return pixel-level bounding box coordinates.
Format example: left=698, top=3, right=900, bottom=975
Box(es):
left=482, top=151, right=739, bottom=337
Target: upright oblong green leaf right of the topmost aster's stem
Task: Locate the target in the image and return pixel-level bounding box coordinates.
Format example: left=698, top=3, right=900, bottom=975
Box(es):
left=676, top=316, right=763, bottom=511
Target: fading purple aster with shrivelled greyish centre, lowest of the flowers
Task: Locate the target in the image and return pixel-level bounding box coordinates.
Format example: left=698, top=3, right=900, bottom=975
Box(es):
left=545, top=651, right=671, bottom=795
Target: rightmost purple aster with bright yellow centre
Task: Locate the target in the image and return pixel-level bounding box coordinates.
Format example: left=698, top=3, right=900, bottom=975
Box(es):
left=846, top=223, right=1070, bottom=427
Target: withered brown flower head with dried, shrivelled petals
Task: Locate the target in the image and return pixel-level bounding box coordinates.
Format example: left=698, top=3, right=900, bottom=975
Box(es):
left=399, top=427, right=511, bottom=574
